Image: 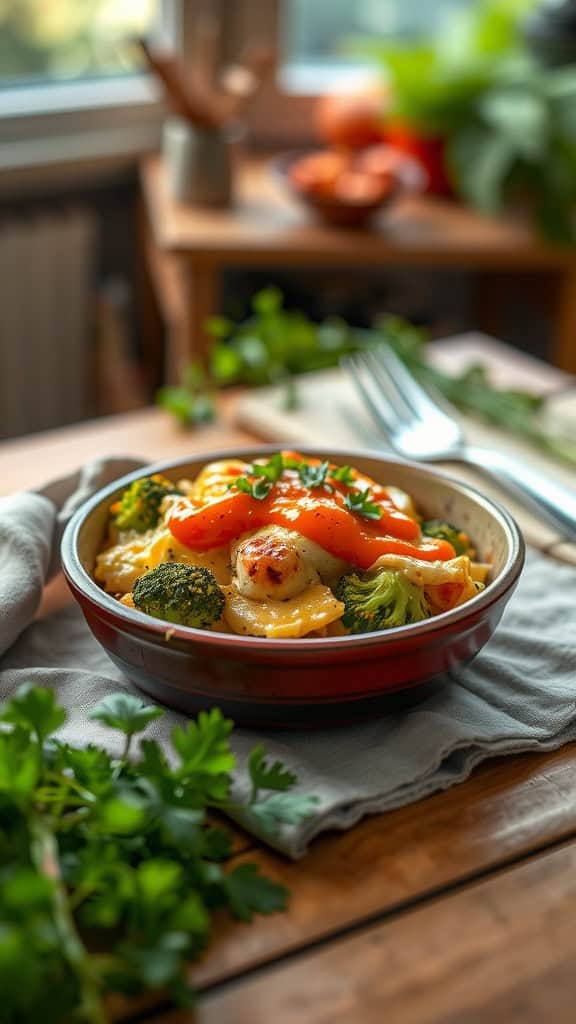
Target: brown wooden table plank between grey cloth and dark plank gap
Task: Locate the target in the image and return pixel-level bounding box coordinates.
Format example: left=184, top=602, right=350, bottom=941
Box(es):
left=179, top=744, right=576, bottom=987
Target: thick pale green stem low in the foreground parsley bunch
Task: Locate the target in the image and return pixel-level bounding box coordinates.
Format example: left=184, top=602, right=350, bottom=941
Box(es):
left=30, top=813, right=108, bottom=1024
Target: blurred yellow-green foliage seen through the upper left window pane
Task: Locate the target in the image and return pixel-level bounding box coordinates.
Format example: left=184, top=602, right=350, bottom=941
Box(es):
left=0, top=0, right=158, bottom=87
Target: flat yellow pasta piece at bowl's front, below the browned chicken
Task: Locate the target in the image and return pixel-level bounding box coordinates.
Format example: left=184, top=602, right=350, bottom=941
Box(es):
left=224, top=583, right=344, bottom=639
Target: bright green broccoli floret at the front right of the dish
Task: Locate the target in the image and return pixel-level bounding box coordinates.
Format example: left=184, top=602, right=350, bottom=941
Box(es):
left=336, top=569, right=429, bottom=633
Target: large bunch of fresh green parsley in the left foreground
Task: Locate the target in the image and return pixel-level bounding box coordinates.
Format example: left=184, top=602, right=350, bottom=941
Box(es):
left=0, top=686, right=315, bottom=1024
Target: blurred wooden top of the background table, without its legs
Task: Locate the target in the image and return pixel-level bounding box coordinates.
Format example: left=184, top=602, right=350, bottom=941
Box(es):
left=140, top=157, right=571, bottom=269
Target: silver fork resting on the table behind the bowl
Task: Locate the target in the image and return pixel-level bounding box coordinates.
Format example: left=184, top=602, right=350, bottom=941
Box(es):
left=344, top=345, right=576, bottom=541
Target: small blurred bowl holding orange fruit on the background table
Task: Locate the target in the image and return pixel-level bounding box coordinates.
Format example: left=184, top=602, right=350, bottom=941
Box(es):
left=272, top=150, right=426, bottom=228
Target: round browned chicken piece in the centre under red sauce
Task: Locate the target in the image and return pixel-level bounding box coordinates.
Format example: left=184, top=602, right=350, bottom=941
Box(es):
left=231, top=525, right=346, bottom=601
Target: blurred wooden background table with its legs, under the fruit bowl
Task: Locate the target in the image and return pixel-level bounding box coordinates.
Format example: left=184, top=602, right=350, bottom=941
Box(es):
left=140, top=157, right=576, bottom=382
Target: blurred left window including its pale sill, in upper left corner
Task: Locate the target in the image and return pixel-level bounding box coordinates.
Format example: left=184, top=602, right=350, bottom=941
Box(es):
left=0, top=0, right=168, bottom=182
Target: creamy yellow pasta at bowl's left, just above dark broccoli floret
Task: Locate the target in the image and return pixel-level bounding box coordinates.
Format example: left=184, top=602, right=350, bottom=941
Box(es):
left=94, top=528, right=231, bottom=594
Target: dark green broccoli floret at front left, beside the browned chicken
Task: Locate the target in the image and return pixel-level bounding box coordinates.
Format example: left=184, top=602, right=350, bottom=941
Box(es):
left=132, top=562, right=224, bottom=630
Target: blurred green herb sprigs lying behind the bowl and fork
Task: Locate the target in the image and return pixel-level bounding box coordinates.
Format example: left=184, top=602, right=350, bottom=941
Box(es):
left=158, top=288, right=576, bottom=468
